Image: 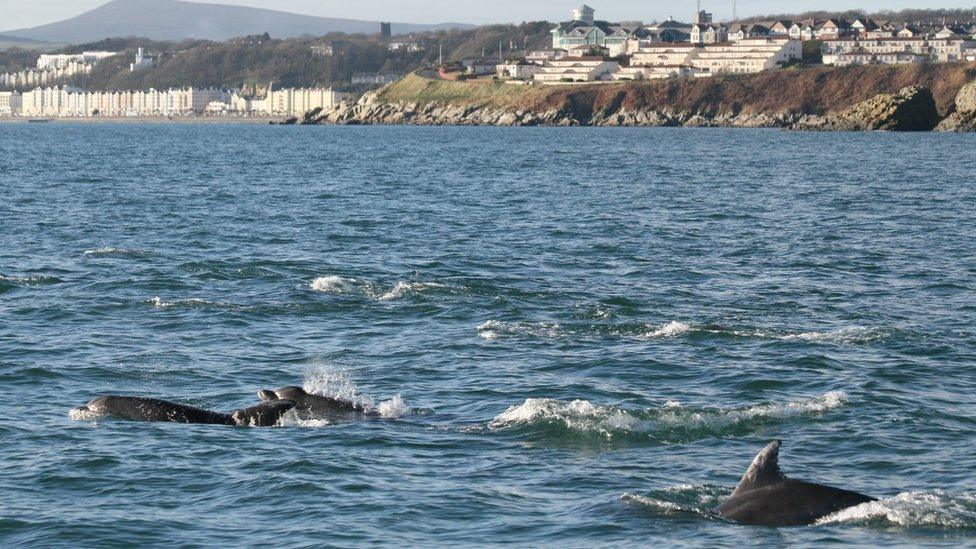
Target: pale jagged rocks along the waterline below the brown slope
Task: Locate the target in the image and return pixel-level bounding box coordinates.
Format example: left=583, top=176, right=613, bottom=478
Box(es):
left=303, top=81, right=939, bottom=131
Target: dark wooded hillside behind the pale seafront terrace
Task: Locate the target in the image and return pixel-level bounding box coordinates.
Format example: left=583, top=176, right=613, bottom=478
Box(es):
left=0, top=21, right=552, bottom=90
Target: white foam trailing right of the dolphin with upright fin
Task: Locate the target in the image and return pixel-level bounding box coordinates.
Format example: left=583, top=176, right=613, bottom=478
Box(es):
left=817, top=490, right=976, bottom=529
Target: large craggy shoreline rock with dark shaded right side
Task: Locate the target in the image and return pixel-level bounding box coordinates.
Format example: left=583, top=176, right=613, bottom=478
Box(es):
left=796, top=86, right=940, bottom=132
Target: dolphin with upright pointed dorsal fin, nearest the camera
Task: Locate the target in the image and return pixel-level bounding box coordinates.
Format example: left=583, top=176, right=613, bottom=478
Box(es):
left=712, top=441, right=877, bottom=526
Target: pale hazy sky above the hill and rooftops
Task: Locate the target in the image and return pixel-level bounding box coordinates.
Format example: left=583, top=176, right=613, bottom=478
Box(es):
left=0, top=0, right=976, bottom=29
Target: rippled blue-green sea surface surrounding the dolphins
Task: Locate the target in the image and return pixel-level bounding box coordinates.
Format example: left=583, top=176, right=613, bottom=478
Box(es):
left=0, top=123, right=976, bottom=547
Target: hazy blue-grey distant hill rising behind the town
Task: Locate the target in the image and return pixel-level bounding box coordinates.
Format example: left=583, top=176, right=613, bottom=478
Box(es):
left=4, top=0, right=471, bottom=44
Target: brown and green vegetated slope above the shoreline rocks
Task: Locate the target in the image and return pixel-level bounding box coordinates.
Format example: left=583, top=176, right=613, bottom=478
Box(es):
left=380, top=63, right=976, bottom=114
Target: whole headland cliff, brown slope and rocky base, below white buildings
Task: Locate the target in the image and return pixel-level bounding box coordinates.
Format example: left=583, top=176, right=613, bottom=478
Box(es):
left=308, top=64, right=976, bottom=131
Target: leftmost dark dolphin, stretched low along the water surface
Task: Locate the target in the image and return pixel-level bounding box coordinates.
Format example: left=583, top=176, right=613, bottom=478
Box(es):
left=71, top=396, right=295, bottom=427
